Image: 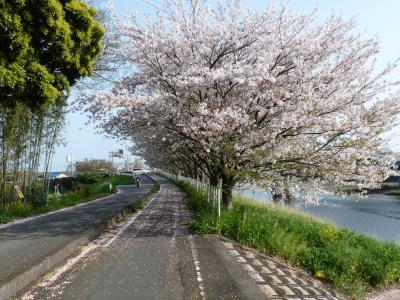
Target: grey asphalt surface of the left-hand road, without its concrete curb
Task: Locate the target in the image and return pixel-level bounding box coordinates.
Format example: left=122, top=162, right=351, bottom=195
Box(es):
left=0, top=176, right=153, bottom=292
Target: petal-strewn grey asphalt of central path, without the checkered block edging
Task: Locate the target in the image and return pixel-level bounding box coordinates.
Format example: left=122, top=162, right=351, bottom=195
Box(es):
left=25, top=177, right=265, bottom=300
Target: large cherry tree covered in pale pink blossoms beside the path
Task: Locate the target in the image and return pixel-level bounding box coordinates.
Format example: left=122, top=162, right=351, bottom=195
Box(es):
left=81, top=0, right=400, bottom=205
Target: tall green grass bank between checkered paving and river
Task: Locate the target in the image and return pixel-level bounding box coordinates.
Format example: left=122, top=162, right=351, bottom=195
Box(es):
left=177, top=182, right=400, bottom=298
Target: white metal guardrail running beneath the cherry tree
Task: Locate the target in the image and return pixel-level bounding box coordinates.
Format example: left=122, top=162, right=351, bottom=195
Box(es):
left=155, top=170, right=222, bottom=218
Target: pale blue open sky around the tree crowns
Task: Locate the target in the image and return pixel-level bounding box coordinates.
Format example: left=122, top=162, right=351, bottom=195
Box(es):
left=52, top=0, right=400, bottom=171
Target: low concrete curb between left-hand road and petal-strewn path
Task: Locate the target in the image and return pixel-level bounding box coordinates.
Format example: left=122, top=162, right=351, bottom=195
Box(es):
left=0, top=176, right=156, bottom=300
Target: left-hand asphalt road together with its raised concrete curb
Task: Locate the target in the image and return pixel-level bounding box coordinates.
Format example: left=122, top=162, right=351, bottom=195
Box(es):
left=0, top=176, right=153, bottom=299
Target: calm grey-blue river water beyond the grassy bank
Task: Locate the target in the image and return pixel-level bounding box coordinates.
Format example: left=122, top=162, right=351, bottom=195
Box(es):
left=234, top=190, right=400, bottom=243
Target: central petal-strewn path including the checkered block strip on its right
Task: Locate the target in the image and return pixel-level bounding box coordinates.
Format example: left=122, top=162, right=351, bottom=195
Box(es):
left=20, top=176, right=341, bottom=300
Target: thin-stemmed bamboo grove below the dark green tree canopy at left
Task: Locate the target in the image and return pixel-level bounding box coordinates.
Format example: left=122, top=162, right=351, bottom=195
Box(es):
left=0, top=101, right=65, bottom=205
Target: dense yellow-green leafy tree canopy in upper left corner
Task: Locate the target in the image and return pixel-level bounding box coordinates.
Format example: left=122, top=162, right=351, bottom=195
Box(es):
left=0, top=0, right=104, bottom=109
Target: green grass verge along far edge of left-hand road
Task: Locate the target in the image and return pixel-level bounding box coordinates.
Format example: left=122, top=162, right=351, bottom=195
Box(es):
left=0, top=175, right=134, bottom=223
